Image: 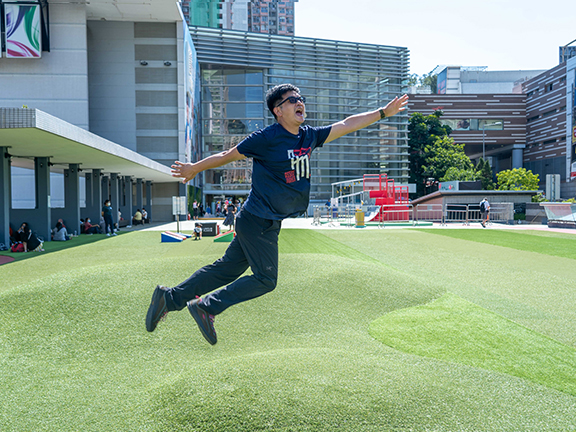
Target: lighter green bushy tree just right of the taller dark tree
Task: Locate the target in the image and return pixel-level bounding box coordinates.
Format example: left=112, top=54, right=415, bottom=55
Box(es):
left=422, top=136, right=474, bottom=181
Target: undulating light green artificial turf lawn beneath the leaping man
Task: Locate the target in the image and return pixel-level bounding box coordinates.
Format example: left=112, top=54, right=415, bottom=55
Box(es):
left=0, top=229, right=576, bottom=431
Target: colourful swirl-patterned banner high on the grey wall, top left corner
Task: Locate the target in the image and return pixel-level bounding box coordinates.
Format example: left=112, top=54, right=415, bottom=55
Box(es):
left=3, top=3, right=42, bottom=58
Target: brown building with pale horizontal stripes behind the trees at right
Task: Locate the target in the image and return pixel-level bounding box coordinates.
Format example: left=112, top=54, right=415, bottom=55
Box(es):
left=410, top=58, right=576, bottom=198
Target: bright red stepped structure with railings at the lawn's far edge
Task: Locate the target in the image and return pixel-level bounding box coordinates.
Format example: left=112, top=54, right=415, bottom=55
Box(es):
left=363, top=174, right=410, bottom=222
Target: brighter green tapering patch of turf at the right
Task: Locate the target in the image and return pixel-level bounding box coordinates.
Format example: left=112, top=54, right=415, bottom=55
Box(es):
left=370, top=294, right=576, bottom=396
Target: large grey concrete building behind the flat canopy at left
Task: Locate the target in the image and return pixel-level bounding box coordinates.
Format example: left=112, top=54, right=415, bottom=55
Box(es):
left=0, top=0, right=194, bottom=235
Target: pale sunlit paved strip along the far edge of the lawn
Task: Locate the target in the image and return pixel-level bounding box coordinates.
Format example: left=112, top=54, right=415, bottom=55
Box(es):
left=136, top=218, right=576, bottom=234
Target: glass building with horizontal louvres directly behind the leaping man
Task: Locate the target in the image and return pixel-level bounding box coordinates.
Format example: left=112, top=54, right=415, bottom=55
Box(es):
left=190, top=27, right=409, bottom=208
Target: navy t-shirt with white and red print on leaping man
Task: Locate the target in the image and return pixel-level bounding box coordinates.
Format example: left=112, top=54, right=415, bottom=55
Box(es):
left=237, top=123, right=332, bottom=220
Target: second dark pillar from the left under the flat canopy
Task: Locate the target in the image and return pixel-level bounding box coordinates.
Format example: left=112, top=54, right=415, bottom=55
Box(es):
left=34, top=157, right=52, bottom=241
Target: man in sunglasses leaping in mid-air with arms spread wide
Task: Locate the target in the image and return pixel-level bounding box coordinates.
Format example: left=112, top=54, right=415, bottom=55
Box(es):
left=146, top=84, right=408, bottom=345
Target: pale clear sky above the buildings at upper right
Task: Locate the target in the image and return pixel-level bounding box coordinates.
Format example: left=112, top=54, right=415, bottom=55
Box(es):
left=295, top=0, right=576, bottom=75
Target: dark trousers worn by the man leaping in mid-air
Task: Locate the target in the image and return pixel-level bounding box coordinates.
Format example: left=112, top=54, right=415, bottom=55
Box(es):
left=166, top=210, right=282, bottom=315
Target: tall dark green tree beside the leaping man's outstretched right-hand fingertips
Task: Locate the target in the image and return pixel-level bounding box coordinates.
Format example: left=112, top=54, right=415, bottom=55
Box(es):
left=408, top=110, right=452, bottom=196
